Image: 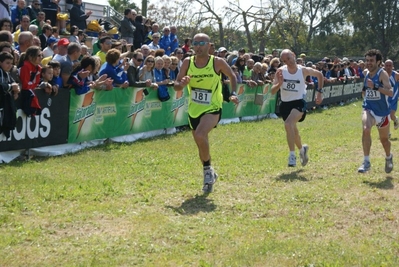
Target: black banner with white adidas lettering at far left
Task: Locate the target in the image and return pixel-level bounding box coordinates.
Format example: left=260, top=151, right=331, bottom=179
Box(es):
left=0, top=89, right=69, bottom=151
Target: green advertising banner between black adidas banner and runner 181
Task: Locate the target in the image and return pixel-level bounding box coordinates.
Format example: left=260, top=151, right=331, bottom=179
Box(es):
left=68, top=88, right=188, bottom=143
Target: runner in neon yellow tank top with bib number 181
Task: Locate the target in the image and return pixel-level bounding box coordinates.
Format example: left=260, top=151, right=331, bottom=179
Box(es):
left=174, top=33, right=238, bottom=193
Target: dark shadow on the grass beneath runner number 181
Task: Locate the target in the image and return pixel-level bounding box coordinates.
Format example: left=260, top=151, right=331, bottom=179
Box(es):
left=166, top=194, right=216, bottom=215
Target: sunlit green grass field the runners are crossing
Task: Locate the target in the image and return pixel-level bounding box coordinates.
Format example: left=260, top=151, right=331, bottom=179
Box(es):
left=0, top=101, right=399, bottom=266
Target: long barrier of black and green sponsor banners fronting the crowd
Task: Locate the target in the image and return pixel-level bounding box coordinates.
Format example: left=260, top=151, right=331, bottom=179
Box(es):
left=0, top=80, right=363, bottom=162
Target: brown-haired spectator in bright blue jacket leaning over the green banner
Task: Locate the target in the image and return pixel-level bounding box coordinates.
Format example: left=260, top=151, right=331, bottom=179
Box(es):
left=100, top=48, right=129, bottom=88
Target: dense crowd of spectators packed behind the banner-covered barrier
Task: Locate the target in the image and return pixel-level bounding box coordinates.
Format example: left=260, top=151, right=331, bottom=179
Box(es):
left=0, top=0, right=364, bottom=122
